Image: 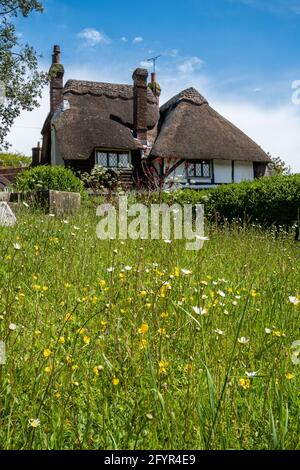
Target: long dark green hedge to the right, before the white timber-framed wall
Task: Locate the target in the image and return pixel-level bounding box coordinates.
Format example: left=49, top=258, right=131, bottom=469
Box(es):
left=146, top=174, right=300, bottom=227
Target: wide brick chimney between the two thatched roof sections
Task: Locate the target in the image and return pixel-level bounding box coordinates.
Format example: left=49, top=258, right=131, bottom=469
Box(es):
left=132, top=69, right=148, bottom=144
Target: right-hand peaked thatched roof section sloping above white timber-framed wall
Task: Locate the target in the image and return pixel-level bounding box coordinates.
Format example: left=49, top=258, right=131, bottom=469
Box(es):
left=150, top=88, right=270, bottom=162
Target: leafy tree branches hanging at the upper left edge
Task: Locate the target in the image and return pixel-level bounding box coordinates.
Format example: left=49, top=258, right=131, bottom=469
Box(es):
left=0, top=0, right=47, bottom=149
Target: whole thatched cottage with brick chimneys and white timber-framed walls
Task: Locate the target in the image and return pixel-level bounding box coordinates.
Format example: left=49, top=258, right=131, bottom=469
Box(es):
left=34, top=46, right=270, bottom=188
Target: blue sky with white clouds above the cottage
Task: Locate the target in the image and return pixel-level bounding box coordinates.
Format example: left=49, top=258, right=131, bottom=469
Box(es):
left=6, top=0, right=300, bottom=171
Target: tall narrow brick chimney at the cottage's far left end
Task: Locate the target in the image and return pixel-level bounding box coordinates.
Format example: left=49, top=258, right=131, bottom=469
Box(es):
left=49, top=46, right=65, bottom=113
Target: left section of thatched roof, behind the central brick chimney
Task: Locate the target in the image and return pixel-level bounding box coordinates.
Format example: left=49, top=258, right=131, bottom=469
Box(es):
left=53, top=80, right=159, bottom=160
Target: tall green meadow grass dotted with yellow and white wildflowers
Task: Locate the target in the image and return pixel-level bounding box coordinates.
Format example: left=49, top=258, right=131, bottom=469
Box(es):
left=0, top=210, right=300, bottom=449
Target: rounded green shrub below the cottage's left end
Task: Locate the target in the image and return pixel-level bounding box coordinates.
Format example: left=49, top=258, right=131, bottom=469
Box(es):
left=15, top=166, right=85, bottom=195
